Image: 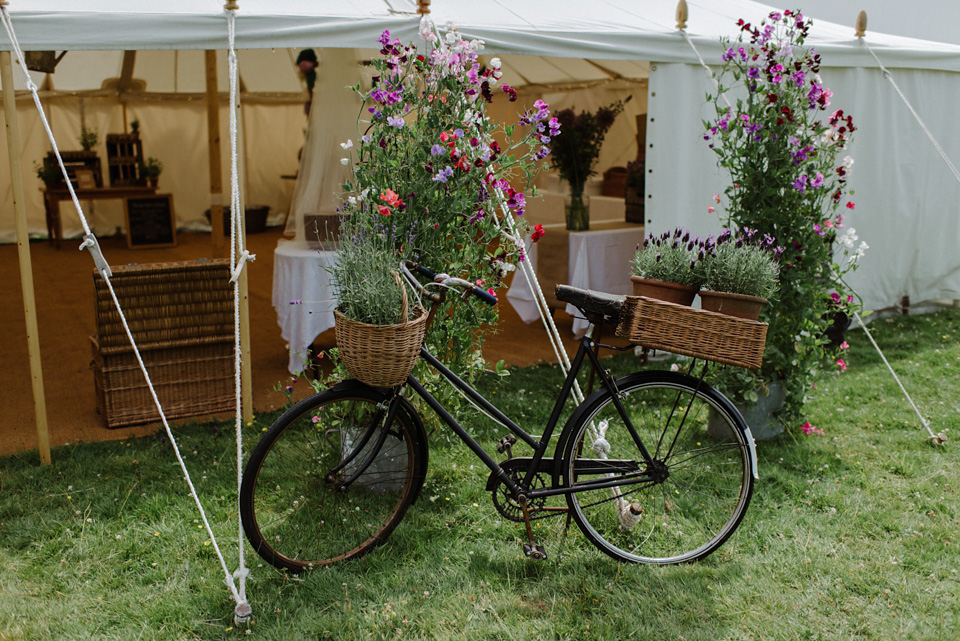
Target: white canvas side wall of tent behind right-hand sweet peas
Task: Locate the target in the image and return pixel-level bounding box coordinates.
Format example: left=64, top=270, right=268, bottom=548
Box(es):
left=646, top=62, right=960, bottom=310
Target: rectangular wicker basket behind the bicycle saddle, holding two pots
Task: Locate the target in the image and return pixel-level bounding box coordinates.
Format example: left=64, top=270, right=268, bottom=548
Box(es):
left=617, top=296, right=767, bottom=369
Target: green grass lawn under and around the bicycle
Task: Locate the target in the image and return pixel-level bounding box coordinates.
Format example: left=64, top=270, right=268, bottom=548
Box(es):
left=0, top=310, right=960, bottom=641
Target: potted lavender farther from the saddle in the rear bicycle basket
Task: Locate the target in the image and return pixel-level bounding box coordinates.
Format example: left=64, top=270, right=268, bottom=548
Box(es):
left=700, top=228, right=782, bottom=320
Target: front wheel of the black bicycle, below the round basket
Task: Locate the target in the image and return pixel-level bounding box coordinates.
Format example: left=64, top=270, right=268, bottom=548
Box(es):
left=240, top=381, right=427, bottom=572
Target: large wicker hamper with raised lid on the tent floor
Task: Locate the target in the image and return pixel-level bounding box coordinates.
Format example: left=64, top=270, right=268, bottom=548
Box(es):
left=90, top=260, right=235, bottom=428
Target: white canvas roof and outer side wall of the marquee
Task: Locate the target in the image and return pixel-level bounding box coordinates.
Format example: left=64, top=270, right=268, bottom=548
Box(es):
left=0, top=0, right=960, bottom=316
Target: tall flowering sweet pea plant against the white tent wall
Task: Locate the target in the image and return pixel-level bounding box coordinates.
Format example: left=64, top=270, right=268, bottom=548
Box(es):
left=704, top=10, right=866, bottom=424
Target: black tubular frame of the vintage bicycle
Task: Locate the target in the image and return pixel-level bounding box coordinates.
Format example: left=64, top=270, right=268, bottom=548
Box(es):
left=398, top=325, right=652, bottom=499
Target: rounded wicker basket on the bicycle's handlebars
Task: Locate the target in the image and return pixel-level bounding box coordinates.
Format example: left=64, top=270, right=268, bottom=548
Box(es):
left=333, top=307, right=427, bottom=387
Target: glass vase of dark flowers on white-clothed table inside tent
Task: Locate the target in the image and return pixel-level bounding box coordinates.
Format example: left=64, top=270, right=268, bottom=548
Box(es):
left=550, top=96, right=632, bottom=230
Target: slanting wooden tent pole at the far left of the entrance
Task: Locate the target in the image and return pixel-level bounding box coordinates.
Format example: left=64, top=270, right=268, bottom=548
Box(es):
left=0, top=51, right=51, bottom=465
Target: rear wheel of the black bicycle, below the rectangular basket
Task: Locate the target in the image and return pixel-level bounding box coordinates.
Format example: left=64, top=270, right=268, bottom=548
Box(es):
left=562, top=372, right=753, bottom=564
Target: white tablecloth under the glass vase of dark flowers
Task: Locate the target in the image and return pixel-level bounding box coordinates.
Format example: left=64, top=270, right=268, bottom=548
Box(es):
left=507, top=225, right=643, bottom=337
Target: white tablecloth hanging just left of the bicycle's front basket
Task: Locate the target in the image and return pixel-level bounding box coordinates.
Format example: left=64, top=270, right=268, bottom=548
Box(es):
left=273, top=240, right=337, bottom=374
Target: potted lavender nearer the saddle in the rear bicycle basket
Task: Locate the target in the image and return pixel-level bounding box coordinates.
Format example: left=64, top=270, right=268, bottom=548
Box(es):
left=630, top=228, right=704, bottom=305
